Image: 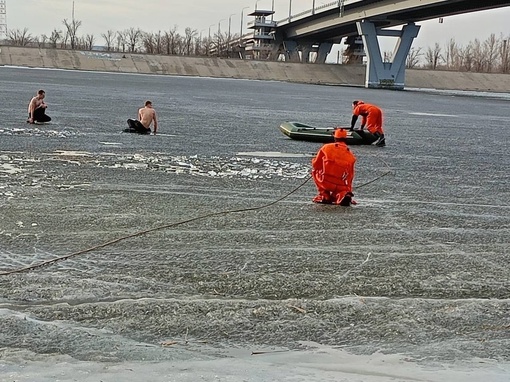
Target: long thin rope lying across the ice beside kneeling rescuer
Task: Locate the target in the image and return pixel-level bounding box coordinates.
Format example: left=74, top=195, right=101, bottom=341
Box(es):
left=0, top=166, right=391, bottom=276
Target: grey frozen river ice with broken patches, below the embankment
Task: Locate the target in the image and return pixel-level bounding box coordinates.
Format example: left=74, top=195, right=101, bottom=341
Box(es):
left=0, top=68, right=510, bottom=381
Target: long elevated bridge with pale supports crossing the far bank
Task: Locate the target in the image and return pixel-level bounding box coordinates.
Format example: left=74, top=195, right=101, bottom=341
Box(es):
left=237, top=0, right=510, bottom=89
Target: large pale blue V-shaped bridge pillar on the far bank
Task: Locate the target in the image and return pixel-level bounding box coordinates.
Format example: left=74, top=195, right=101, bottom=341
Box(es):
left=356, top=21, right=420, bottom=90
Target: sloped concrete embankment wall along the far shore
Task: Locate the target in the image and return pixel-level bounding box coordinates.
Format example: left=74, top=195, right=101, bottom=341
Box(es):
left=0, top=46, right=510, bottom=92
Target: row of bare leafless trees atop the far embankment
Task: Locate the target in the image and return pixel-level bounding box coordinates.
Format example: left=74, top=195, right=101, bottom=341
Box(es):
left=3, top=19, right=510, bottom=73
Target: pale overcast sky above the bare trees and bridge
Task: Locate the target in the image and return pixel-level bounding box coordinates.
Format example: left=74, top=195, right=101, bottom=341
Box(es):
left=6, top=0, right=510, bottom=50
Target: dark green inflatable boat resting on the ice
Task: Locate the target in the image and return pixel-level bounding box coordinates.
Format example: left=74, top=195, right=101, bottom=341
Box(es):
left=280, top=122, right=377, bottom=145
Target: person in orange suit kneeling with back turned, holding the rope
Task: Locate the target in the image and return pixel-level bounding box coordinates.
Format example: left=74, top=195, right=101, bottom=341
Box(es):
left=312, top=129, right=356, bottom=206
